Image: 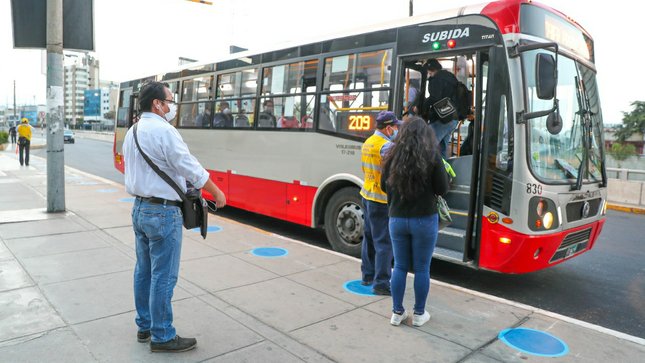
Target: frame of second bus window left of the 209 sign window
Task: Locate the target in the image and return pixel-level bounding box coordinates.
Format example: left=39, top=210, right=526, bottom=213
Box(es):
left=211, top=66, right=260, bottom=130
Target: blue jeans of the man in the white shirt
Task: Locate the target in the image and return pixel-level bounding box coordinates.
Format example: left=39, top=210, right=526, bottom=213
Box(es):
left=132, top=199, right=182, bottom=343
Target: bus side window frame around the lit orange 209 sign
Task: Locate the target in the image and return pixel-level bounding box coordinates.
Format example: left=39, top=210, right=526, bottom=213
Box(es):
left=316, top=45, right=396, bottom=141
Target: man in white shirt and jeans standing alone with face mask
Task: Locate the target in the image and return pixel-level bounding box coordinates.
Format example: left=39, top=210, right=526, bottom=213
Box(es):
left=123, top=82, right=226, bottom=352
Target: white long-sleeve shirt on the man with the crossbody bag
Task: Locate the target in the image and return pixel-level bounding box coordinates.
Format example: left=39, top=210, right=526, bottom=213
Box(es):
left=123, top=112, right=209, bottom=201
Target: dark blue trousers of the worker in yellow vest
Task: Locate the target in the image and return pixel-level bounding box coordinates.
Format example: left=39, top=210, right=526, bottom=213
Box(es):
left=361, top=199, right=392, bottom=289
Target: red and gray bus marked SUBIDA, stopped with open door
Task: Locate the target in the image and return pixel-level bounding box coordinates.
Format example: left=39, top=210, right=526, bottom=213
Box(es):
left=114, top=0, right=607, bottom=273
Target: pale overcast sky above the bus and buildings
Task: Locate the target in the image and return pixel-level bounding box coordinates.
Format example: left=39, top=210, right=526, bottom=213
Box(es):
left=0, top=0, right=645, bottom=124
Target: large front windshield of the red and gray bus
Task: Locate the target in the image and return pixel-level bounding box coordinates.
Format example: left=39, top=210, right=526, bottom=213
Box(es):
left=522, top=49, right=602, bottom=183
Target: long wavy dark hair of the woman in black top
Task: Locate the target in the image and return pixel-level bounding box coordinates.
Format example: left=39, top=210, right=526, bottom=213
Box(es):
left=383, top=116, right=439, bottom=200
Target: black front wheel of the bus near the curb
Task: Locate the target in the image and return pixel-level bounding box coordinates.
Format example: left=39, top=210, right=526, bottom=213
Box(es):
left=325, top=187, right=365, bottom=257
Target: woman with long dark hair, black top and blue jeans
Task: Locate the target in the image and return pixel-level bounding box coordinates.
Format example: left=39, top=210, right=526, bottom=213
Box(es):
left=381, top=117, right=449, bottom=326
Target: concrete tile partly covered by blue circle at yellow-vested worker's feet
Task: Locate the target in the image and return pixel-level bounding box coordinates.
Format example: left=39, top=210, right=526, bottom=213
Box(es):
left=288, top=258, right=382, bottom=306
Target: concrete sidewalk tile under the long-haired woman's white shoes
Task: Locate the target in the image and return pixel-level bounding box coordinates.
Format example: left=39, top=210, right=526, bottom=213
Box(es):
left=365, top=284, right=531, bottom=349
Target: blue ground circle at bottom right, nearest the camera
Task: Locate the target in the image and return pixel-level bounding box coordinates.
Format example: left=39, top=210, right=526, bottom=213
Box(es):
left=498, top=328, right=569, bottom=357
